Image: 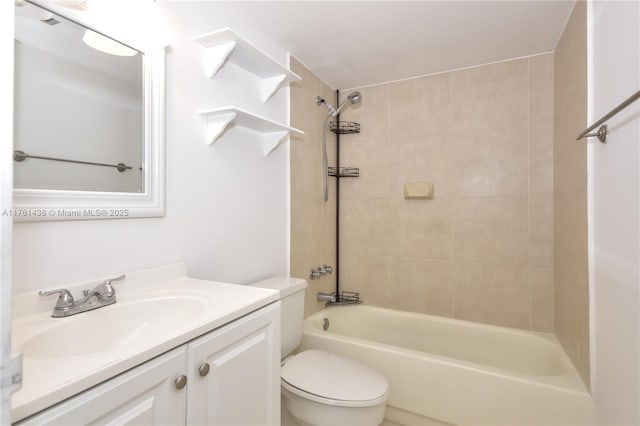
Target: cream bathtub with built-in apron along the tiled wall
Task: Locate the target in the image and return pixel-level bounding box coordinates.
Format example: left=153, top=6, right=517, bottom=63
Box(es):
left=301, top=305, right=593, bottom=426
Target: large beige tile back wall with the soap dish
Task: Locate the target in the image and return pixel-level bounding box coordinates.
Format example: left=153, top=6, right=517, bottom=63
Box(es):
left=340, top=54, right=555, bottom=332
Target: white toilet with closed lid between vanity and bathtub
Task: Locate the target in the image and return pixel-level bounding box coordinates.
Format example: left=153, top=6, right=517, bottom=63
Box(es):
left=251, top=277, right=389, bottom=426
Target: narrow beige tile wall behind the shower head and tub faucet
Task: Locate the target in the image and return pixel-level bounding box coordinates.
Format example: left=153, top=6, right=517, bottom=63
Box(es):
left=290, top=57, right=336, bottom=316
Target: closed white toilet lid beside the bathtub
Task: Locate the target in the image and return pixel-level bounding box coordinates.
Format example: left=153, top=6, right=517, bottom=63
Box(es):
left=281, top=349, right=389, bottom=402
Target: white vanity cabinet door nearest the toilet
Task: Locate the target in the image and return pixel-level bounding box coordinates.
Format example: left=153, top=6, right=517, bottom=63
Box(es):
left=187, top=302, right=280, bottom=426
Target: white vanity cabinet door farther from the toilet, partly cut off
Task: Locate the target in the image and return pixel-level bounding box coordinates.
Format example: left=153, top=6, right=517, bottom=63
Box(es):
left=18, top=346, right=187, bottom=426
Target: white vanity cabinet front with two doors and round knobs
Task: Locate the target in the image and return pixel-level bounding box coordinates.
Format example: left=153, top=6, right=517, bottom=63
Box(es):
left=17, top=302, right=280, bottom=426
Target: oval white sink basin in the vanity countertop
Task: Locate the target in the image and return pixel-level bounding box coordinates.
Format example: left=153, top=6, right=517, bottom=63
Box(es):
left=20, top=297, right=206, bottom=359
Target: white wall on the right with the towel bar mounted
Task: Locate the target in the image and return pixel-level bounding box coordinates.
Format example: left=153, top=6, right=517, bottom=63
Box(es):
left=589, top=1, right=640, bottom=425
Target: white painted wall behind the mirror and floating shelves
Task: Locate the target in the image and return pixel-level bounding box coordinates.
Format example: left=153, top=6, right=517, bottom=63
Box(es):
left=13, top=1, right=289, bottom=293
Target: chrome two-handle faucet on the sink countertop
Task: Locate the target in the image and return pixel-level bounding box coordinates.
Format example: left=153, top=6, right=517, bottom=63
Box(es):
left=38, top=275, right=126, bottom=318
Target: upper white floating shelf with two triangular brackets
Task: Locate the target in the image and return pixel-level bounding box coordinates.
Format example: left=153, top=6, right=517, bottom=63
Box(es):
left=194, top=28, right=302, bottom=102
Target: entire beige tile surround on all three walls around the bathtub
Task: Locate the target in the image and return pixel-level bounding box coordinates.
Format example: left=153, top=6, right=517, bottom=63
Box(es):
left=291, top=8, right=589, bottom=384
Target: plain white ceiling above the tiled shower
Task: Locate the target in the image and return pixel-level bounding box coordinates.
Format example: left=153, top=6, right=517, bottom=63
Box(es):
left=225, top=0, right=575, bottom=89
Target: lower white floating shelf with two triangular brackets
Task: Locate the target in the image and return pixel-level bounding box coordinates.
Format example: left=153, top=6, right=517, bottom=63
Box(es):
left=198, top=106, right=304, bottom=156
